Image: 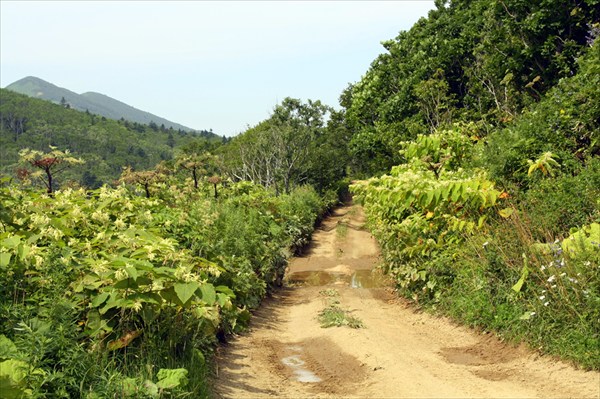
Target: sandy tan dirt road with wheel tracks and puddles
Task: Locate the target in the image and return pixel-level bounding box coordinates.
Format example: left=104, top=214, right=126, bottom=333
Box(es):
left=214, top=206, right=600, bottom=398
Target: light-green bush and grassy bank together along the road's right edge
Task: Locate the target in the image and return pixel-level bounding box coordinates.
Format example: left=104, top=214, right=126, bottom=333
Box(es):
left=352, top=123, right=600, bottom=370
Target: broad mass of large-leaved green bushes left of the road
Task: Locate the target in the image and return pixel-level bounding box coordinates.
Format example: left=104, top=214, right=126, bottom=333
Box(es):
left=0, top=177, right=324, bottom=398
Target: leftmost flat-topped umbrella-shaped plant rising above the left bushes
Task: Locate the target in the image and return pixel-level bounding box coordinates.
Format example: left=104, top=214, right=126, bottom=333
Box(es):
left=19, top=146, right=85, bottom=195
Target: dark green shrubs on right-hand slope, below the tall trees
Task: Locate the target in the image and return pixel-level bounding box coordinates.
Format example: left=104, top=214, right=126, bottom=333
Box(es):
left=485, top=42, right=600, bottom=187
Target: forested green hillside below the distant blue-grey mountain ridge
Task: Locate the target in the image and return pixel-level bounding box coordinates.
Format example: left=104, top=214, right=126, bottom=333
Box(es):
left=0, top=89, right=222, bottom=187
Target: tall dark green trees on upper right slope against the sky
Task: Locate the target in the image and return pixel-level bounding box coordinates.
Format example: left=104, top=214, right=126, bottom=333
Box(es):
left=340, top=0, right=600, bottom=174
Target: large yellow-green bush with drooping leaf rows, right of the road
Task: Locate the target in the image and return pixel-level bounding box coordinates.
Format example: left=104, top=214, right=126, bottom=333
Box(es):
left=352, top=126, right=503, bottom=299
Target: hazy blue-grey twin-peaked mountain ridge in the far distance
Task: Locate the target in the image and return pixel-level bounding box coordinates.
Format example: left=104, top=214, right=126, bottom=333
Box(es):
left=6, top=76, right=195, bottom=132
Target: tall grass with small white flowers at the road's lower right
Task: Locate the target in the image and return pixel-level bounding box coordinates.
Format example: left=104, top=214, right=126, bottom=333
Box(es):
left=430, top=206, right=600, bottom=370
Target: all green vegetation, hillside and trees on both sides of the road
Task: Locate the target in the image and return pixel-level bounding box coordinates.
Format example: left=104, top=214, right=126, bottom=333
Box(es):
left=0, top=0, right=600, bottom=398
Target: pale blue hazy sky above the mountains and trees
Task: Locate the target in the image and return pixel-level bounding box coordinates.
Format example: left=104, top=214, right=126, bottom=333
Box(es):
left=0, top=0, right=434, bottom=136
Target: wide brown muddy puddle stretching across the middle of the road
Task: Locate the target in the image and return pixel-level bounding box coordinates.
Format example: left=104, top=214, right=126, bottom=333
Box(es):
left=287, top=270, right=386, bottom=288
